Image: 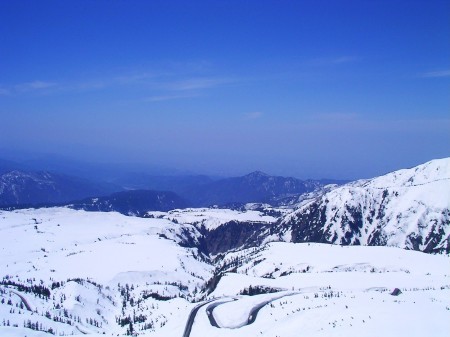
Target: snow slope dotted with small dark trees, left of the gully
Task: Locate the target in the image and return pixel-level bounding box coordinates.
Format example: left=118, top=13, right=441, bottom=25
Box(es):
left=0, top=208, right=213, bottom=335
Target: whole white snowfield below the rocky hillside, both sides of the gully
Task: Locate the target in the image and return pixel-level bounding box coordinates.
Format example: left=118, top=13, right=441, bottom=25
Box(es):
left=0, top=201, right=450, bottom=337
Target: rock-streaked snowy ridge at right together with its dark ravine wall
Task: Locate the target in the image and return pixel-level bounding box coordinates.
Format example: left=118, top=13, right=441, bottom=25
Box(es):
left=191, top=158, right=450, bottom=254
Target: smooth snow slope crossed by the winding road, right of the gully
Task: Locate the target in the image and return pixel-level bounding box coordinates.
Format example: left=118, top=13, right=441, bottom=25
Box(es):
left=192, top=242, right=450, bottom=337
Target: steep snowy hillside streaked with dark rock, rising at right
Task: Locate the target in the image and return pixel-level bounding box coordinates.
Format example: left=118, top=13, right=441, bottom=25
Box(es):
left=278, top=158, right=450, bottom=254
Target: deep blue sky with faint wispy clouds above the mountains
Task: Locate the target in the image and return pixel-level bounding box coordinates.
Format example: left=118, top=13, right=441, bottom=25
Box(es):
left=0, top=0, right=450, bottom=179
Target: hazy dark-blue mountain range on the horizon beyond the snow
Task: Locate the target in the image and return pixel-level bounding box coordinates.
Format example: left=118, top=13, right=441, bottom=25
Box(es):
left=0, top=161, right=342, bottom=207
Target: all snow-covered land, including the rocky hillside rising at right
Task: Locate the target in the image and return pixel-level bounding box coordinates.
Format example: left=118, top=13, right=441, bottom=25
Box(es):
left=0, top=159, right=450, bottom=337
